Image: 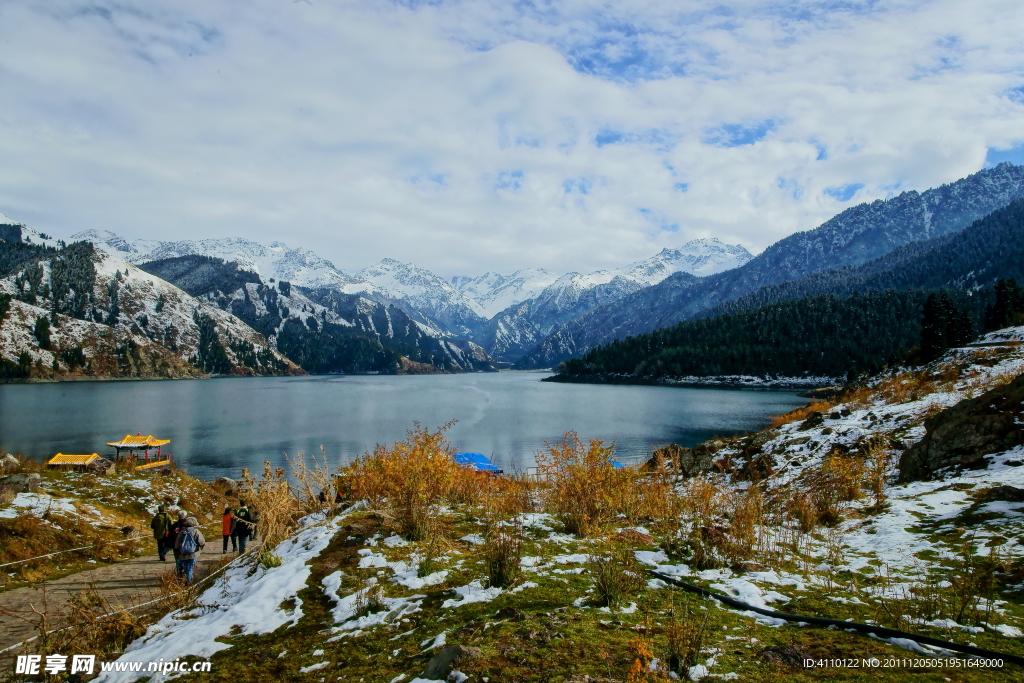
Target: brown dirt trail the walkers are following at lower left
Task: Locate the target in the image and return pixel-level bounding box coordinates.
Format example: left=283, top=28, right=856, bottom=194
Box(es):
left=0, top=538, right=234, bottom=663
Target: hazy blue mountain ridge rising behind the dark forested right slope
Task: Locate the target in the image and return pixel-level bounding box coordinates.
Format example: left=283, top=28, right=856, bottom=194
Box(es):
left=517, top=163, right=1024, bottom=368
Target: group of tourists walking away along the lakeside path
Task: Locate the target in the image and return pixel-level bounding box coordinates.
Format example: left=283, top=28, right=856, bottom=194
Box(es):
left=150, top=501, right=258, bottom=583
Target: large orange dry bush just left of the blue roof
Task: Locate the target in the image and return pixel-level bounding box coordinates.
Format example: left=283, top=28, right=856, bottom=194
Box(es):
left=343, top=423, right=462, bottom=541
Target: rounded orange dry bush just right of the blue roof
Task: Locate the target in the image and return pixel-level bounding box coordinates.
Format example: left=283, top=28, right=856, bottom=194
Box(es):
left=537, top=432, right=640, bottom=537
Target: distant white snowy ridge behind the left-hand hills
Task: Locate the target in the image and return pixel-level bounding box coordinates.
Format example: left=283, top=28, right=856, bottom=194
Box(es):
left=72, top=230, right=360, bottom=289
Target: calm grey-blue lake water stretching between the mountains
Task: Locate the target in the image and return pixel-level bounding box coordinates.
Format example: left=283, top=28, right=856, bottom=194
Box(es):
left=0, top=373, right=805, bottom=478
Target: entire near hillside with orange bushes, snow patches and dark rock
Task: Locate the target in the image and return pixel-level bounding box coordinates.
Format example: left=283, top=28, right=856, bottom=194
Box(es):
left=61, top=344, right=1024, bottom=683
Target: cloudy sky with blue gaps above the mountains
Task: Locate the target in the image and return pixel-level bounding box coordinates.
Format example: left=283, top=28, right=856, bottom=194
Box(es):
left=0, top=0, right=1024, bottom=275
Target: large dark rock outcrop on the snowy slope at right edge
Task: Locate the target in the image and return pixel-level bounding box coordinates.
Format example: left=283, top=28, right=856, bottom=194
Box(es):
left=899, top=375, right=1024, bottom=483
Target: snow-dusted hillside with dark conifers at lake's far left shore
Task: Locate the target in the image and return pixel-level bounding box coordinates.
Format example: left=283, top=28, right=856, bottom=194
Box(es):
left=0, top=226, right=301, bottom=378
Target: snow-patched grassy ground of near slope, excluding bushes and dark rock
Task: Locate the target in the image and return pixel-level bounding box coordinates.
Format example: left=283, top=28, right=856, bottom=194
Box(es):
left=94, top=346, right=1024, bottom=683
